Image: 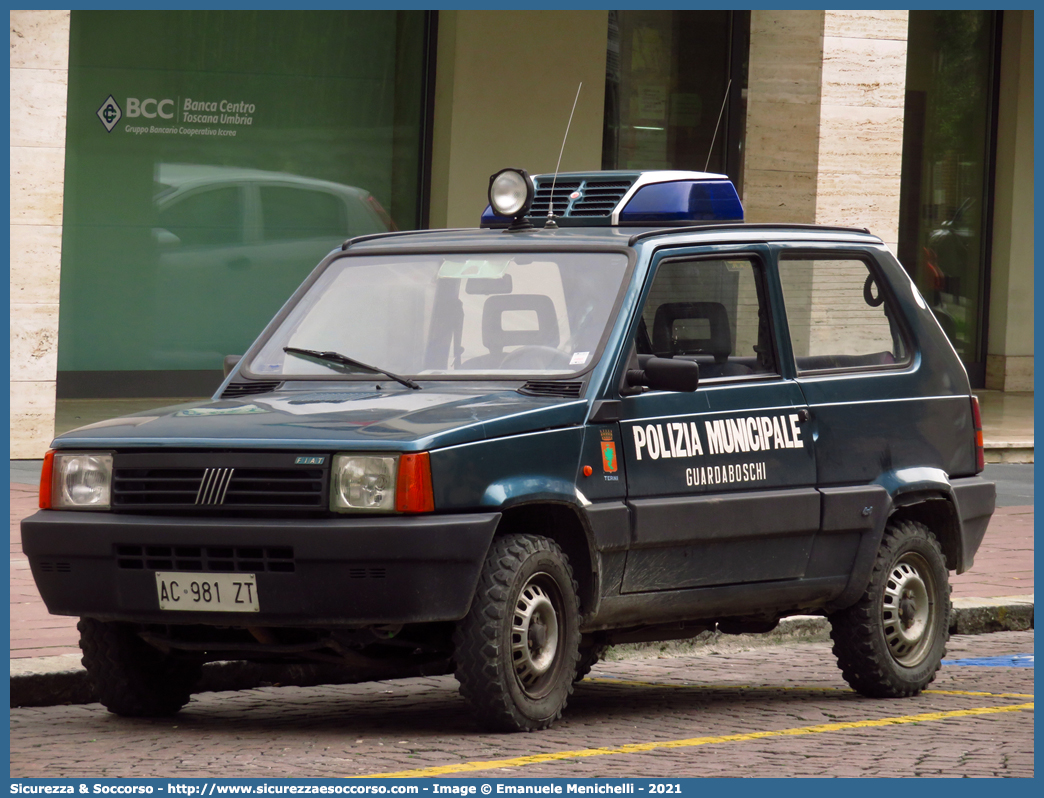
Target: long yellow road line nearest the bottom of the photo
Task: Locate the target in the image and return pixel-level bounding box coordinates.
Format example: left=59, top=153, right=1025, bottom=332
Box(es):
left=352, top=702, right=1034, bottom=778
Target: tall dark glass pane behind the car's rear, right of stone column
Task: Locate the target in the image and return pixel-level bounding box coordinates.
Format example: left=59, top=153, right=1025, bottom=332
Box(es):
left=898, top=10, right=998, bottom=385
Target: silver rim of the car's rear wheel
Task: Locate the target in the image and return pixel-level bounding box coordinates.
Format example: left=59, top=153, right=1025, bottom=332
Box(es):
left=881, top=551, right=936, bottom=667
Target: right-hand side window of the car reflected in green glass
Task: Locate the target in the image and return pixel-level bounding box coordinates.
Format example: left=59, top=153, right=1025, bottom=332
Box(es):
left=261, top=186, right=352, bottom=241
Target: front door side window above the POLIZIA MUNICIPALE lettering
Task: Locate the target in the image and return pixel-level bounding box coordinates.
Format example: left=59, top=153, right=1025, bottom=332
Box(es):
left=636, top=259, right=776, bottom=379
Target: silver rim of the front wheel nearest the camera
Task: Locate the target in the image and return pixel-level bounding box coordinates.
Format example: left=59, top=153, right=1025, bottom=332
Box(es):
left=512, top=573, right=560, bottom=698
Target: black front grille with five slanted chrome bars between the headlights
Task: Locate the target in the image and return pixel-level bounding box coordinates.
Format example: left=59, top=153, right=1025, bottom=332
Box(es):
left=113, top=452, right=330, bottom=514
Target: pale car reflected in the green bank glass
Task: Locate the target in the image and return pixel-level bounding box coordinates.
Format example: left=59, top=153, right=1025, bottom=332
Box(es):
left=153, top=164, right=395, bottom=369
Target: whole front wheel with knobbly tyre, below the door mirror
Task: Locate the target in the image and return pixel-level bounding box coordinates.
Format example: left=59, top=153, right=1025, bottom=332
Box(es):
left=453, top=535, right=580, bottom=731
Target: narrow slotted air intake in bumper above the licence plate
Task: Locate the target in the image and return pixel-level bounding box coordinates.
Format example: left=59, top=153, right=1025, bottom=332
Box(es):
left=116, top=543, right=296, bottom=573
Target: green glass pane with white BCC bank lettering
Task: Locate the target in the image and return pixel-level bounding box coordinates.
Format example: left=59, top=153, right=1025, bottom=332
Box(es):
left=58, top=11, right=429, bottom=398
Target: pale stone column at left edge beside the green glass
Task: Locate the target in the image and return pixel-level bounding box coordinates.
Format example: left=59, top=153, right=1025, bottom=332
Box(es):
left=10, top=10, right=69, bottom=460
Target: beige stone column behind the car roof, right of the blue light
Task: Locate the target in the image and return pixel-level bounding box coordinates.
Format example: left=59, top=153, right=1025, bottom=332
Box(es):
left=743, top=10, right=908, bottom=251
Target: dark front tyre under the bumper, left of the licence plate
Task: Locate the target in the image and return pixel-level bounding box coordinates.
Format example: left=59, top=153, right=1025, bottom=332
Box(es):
left=76, top=618, right=201, bottom=718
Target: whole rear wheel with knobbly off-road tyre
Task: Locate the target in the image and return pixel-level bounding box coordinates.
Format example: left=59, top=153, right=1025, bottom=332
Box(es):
left=829, top=520, right=950, bottom=698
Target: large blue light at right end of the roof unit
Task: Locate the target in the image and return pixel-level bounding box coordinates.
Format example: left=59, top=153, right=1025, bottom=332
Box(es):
left=620, top=180, right=743, bottom=225
